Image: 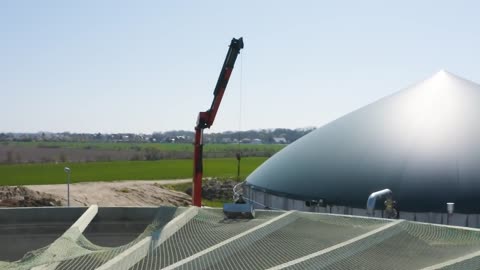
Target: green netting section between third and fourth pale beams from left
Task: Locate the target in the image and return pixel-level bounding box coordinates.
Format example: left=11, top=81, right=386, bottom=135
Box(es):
left=174, top=212, right=388, bottom=269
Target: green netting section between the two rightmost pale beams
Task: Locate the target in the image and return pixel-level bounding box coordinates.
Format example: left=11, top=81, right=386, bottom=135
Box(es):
left=288, top=221, right=480, bottom=269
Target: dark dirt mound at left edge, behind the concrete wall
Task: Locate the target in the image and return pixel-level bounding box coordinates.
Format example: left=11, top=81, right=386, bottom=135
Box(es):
left=0, top=186, right=61, bottom=207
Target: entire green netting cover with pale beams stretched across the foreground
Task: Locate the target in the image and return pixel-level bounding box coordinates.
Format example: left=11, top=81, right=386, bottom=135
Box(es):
left=0, top=208, right=480, bottom=270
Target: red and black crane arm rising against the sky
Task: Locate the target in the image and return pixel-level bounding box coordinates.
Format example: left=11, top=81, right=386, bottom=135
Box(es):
left=192, top=38, right=243, bottom=207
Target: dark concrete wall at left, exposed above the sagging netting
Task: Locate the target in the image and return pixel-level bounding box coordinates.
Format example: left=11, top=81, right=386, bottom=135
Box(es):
left=0, top=207, right=163, bottom=262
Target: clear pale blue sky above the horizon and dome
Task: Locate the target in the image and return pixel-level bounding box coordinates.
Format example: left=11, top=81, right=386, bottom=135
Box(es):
left=0, top=0, right=480, bottom=133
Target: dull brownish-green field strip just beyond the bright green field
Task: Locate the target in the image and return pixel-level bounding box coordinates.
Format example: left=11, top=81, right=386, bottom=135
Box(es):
left=0, top=142, right=285, bottom=164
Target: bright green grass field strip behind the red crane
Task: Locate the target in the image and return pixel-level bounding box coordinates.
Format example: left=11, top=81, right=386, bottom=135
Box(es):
left=0, top=157, right=267, bottom=185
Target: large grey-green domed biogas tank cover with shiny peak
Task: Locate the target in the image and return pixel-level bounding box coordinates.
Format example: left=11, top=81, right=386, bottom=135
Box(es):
left=247, top=71, right=480, bottom=213
